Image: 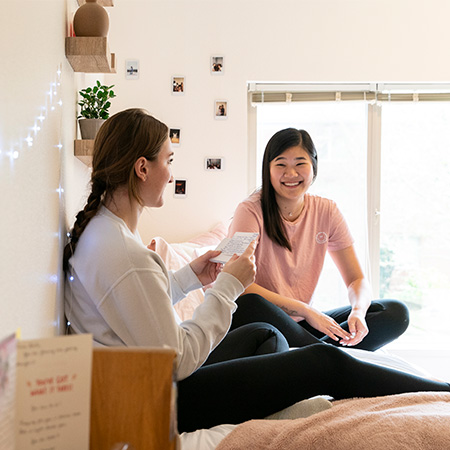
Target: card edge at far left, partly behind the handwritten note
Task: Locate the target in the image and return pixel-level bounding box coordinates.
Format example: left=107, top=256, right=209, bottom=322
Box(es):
left=0, top=334, right=17, bottom=450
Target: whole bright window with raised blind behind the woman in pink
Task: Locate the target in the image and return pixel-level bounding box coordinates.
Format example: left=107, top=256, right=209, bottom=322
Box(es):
left=250, top=85, right=450, bottom=352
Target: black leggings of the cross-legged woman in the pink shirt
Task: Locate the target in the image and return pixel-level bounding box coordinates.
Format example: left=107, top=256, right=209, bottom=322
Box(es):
left=231, top=294, right=409, bottom=351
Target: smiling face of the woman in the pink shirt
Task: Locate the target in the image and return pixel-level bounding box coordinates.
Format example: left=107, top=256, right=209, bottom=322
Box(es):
left=270, top=145, right=314, bottom=205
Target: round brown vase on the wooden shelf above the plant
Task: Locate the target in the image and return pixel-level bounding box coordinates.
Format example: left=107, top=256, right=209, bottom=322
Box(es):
left=73, top=0, right=109, bottom=37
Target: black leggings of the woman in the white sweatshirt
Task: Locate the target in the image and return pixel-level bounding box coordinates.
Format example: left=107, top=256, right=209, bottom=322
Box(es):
left=177, top=323, right=450, bottom=432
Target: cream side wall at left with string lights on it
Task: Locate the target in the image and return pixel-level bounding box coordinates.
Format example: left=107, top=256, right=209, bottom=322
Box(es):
left=0, top=0, right=89, bottom=338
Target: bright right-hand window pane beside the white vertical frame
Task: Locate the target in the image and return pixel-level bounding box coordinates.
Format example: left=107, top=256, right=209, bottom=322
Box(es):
left=379, top=102, right=450, bottom=345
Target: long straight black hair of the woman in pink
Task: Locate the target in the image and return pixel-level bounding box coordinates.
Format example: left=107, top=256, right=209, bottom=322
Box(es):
left=261, top=128, right=317, bottom=251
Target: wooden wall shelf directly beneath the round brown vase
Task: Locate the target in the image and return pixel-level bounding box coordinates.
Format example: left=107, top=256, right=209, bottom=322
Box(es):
left=66, top=37, right=116, bottom=73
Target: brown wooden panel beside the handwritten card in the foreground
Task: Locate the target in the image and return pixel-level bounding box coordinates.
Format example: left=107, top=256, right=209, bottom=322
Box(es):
left=90, top=347, right=178, bottom=450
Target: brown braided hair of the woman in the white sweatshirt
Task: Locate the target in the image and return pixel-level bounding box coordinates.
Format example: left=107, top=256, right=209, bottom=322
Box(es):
left=63, top=109, right=169, bottom=271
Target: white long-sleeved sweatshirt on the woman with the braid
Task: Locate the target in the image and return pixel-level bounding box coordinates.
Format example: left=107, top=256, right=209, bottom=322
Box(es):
left=65, top=207, right=244, bottom=380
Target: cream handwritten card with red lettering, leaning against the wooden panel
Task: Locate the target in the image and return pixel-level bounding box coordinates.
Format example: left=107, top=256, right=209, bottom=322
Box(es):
left=14, top=335, right=92, bottom=450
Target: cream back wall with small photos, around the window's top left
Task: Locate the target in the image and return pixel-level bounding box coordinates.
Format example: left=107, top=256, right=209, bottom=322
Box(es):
left=106, top=0, right=450, bottom=246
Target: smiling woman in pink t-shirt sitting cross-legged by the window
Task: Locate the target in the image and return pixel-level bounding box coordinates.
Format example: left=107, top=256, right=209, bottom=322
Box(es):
left=229, top=128, right=409, bottom=350
